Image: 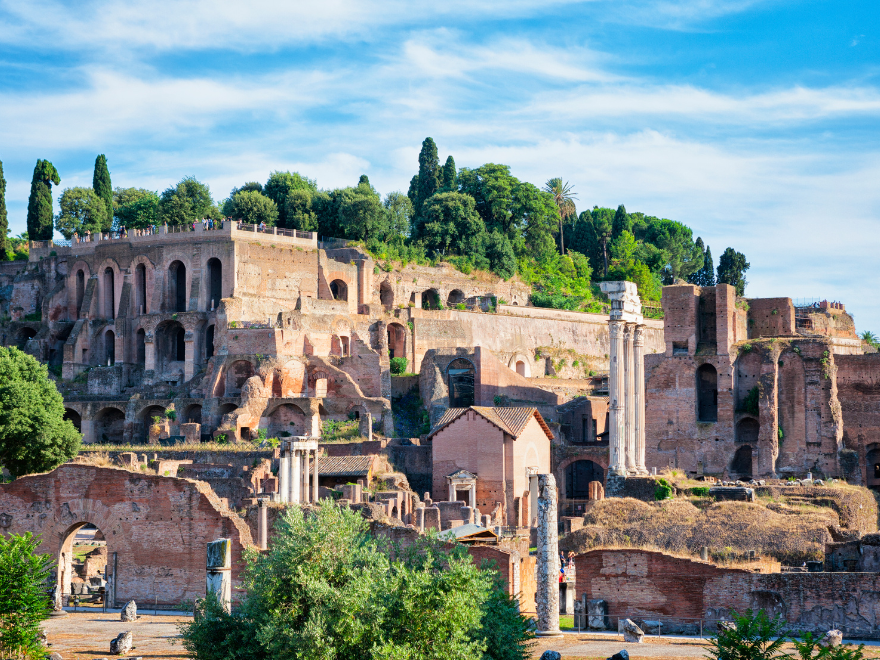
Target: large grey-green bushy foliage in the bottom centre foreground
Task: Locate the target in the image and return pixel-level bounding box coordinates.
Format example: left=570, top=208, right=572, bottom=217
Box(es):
left=181, top=501, right=531, bottom=660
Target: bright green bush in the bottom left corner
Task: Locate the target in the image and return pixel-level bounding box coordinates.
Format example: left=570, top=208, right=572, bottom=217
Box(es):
left=0, top=532, right=52, bottom=660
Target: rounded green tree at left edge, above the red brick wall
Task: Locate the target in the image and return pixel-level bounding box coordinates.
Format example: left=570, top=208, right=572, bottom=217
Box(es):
left=0, top=347, right=82, bottom=478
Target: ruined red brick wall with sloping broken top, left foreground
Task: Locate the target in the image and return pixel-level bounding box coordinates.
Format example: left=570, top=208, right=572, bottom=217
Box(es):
left=0, top=463, right=253, bottom=607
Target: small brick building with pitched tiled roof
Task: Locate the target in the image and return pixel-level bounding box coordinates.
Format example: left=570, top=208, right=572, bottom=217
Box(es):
left=428, top=406, right=553, bottom=526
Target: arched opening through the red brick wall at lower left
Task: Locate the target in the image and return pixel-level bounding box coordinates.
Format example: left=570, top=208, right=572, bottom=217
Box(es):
left=57, top=522, right=113, bottom=607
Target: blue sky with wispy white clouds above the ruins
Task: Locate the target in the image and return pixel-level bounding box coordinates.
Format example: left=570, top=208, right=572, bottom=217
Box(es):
left=0, top=0, right=880, bottom=334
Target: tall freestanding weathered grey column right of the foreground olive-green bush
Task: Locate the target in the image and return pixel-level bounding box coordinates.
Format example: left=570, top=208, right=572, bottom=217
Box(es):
left=535, top=474, right=562, bottom=637
